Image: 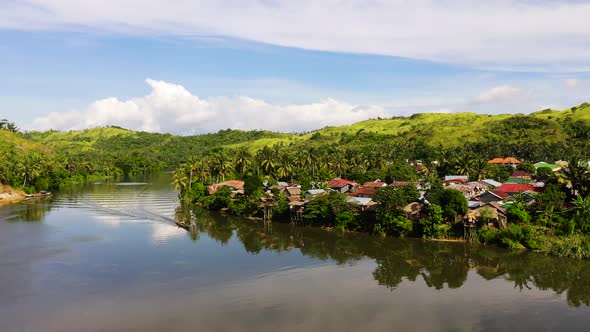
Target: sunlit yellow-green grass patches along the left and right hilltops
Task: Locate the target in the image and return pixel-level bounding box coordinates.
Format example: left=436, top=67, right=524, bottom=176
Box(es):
left=16, top=104, right=590, bottom=152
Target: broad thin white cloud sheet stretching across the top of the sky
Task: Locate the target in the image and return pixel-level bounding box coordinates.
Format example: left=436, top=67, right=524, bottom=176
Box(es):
left=0, top=0, right=590, bottom=71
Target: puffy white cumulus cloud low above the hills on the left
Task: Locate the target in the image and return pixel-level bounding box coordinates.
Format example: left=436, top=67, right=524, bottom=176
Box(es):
left=28, top=79, right=386, bottom=134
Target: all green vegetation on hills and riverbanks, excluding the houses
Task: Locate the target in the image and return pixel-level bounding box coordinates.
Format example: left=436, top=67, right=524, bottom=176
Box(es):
left=0, top=103, right=590, bottom=257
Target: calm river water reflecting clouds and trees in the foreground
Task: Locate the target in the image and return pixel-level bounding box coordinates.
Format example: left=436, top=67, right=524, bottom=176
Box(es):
left=0, top=174, right=590, bottom=332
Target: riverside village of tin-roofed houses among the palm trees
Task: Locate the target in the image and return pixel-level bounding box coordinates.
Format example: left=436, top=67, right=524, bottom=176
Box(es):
left=202, top=157, right=567, bottom=236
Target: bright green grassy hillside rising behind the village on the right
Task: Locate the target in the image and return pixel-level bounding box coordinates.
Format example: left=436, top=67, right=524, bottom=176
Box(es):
left=224, top=103, right=590, bottom=150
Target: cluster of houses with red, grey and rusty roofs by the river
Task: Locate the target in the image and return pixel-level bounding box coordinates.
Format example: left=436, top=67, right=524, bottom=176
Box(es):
left=207, top=157, right=567, bottom=227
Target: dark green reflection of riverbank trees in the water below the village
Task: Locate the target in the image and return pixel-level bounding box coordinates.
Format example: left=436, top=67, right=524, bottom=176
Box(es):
left=176, top=207, right=590, bottom=307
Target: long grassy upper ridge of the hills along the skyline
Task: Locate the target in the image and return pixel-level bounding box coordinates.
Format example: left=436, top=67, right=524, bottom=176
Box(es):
left=21, top=103, right=590, bottom=158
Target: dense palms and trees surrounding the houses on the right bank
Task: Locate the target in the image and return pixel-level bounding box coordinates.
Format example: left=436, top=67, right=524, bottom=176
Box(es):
left=168, top=104, right=590, bottom=257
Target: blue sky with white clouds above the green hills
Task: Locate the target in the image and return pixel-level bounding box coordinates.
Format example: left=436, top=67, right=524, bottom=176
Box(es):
left=0, top=0, right=590, bottom=135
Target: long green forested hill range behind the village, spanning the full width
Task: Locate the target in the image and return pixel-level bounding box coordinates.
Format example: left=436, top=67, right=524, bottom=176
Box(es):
left=0, top=103, right=590, bottom=190
